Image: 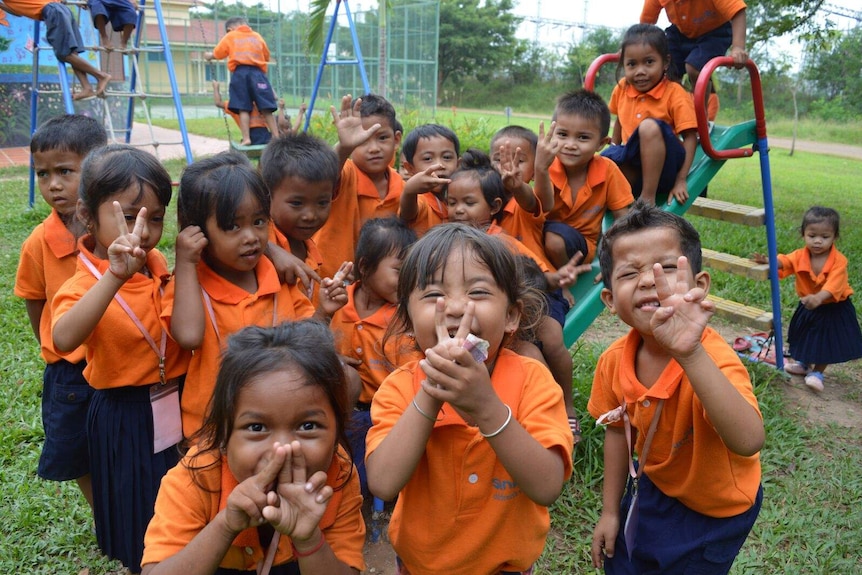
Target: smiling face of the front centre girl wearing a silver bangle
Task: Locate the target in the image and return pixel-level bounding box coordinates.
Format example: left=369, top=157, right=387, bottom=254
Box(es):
left=407, top=248, right=521, bottom=358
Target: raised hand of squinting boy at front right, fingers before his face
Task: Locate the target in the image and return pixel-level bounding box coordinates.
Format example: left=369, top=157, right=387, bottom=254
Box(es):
left=650, top=256, right=715, bottom=358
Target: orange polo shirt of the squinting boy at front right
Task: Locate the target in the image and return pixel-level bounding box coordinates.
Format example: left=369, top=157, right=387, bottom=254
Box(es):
left=587, top=327, right=760, bottom=517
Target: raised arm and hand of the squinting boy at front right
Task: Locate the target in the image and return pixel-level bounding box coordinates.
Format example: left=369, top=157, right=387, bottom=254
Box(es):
left=650, top=257, right=765, bottom=456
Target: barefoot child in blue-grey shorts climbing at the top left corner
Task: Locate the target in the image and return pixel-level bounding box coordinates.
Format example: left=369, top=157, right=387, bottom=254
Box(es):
left=0, top=0, right=111, bottom=101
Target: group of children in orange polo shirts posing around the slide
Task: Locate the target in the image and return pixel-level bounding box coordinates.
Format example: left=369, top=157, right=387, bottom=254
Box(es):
left=16, top=2, right=862, bottom=575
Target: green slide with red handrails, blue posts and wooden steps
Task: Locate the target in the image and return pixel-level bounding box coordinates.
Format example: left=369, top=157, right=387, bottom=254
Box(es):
left=563, top=54, right=784, bottom=370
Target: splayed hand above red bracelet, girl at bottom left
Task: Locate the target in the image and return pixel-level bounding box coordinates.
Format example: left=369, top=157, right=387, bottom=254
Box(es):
left=262, top=441, right=332, bottom=544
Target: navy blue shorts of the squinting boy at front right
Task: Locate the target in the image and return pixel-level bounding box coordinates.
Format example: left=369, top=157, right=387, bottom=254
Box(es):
left=605, top=474, right=763, bottom=575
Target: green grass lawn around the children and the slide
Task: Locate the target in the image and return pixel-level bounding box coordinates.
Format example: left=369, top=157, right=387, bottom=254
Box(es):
left=0, top=143, right=862, bottom=575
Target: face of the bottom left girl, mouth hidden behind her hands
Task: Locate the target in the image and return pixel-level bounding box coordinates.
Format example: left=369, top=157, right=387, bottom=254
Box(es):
left=226, top=367, right=337, bottom=483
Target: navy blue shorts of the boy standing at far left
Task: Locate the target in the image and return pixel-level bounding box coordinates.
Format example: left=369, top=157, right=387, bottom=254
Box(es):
left=38, top=359, right=93, bottom=481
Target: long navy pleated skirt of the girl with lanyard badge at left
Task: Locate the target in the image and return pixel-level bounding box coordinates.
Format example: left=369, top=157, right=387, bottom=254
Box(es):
left=87, top=385, right=180, bottom=573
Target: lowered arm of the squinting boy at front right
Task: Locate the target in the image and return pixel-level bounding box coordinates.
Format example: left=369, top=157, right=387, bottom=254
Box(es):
left=591, top=426, right=629, bottom=569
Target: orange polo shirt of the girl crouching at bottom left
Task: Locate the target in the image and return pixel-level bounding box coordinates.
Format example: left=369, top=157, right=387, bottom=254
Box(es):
left=141, top=448, right=365, bottom=572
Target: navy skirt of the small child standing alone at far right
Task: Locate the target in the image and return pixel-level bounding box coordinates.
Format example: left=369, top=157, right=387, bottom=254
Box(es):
left=787, top=298, right=862, bottom=365
